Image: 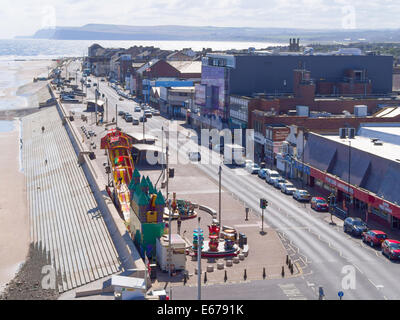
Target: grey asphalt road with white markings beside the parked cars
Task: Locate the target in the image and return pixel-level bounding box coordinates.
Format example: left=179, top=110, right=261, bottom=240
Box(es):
left=69, top=60, right=400, bottom=300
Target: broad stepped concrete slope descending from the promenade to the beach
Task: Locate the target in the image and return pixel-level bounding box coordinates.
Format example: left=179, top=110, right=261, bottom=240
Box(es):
left=22, top=107, right=120, bottom=292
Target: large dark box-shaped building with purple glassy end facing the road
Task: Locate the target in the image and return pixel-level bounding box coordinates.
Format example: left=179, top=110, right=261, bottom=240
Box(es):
left=195, top=53, right=393, bottom=126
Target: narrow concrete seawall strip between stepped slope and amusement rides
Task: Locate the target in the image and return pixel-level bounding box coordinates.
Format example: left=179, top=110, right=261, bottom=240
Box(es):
left=48, top=84, right=145, bottom=277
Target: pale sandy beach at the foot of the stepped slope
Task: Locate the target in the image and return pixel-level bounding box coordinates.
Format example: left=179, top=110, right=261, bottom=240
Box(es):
left=0, top=60, right=54, bottom=292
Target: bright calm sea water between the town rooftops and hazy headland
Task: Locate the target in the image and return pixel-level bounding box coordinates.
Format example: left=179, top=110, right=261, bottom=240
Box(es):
left=0, top=39, right=279, bottom=60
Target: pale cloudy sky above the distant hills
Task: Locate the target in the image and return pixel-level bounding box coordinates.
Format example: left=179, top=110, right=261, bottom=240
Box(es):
left=0, top=0, right=400, bottom=39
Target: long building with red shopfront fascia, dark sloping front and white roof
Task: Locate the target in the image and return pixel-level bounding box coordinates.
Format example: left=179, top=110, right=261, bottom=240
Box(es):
left=304, top=123, right=400, bottom=229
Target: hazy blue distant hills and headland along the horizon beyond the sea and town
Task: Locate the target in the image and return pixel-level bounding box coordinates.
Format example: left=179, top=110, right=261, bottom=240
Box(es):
left=19, top=24, right=400, bottom=43
